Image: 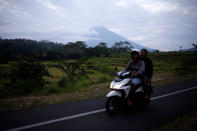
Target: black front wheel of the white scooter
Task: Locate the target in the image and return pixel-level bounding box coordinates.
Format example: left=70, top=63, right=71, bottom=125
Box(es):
left=106, top=96, right=120, bottom=115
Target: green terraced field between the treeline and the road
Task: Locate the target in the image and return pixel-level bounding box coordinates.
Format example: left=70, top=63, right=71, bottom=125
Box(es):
left=0, top=52, right=197, bottom=111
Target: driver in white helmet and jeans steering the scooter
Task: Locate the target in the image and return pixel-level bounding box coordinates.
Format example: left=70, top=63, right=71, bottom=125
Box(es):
left=125, top=49, right=145, bottom=105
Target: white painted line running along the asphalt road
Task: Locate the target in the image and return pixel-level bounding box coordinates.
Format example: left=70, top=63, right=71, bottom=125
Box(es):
left=7, top=86, right=197, bottom=131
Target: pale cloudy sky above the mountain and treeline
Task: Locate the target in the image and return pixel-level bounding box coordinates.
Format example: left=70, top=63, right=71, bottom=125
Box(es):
left=0, top=0, right=197, bottom=50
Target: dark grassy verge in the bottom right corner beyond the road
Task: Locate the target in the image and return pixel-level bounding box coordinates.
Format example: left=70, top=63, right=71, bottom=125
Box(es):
left=151, top=110, right=197, bottom=131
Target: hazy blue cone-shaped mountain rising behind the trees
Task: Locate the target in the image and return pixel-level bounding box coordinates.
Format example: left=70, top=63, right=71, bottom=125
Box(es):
left=85, top=26, right=154, bottom=51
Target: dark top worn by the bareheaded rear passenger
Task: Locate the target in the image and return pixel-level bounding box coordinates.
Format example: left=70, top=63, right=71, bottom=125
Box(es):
left=140, top=57, right=153, bottom=79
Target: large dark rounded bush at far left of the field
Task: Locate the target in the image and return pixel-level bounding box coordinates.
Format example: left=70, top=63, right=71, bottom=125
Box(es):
left=5, top=61, right=50, bottom=96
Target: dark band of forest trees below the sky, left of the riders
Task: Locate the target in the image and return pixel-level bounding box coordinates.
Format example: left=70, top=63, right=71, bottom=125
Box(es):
left=0, top=38, right=132, bottom=63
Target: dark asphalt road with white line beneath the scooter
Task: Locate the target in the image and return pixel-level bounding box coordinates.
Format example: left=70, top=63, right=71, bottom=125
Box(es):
left=0, top=81, right=197, bottom=131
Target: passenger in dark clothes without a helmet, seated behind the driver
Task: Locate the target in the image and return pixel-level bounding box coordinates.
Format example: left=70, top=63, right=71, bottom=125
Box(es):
left=140, top=49, right=153, bottom=99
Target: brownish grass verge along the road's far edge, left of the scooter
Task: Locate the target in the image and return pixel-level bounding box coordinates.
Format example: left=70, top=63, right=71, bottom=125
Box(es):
left=0, top=82, right=110, bottom=112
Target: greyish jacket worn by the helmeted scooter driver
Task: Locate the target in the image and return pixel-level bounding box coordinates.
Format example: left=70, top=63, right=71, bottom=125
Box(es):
left=125, top=60, right=145, bottom=77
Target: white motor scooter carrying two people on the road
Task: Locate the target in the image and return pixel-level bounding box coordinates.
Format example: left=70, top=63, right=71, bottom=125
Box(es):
left=106, top=70, right=152, bottom=115
